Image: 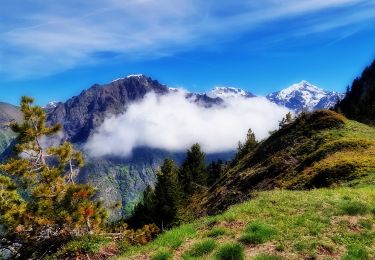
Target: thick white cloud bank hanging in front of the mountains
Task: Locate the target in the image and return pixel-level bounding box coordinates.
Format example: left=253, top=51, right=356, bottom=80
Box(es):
left=86, top=91, right=288, bottom=157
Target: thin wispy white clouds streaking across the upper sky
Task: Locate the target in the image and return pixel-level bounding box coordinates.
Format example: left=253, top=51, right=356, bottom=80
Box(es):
left=0, top=0, right=375, bottom=77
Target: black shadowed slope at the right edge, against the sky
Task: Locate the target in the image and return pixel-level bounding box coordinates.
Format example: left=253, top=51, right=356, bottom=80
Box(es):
left=335, top=58, right=375, bottom=125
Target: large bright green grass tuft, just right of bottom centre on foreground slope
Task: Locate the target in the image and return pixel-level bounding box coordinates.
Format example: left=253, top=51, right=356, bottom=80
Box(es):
left=240, top=222, right=275, bottom=244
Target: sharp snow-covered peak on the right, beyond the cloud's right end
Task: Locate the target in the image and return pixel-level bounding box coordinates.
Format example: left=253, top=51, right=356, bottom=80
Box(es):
left=267, top=80, right=344, bottom=112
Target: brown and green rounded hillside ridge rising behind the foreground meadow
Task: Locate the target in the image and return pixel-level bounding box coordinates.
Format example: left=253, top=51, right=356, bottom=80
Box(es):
left=203, top=111, right=375, bottom=215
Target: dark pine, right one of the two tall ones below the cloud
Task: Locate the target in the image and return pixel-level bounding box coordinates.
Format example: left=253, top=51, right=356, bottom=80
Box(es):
left=179, top=144, right=208, bottom=195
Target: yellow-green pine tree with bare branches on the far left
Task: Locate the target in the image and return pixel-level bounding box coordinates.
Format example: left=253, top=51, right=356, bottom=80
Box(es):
left=0, top=97, right=106, bottom=240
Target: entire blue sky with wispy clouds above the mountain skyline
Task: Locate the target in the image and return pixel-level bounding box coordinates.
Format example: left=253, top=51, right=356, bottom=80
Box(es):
left=0, top=0, right=375, bottom=104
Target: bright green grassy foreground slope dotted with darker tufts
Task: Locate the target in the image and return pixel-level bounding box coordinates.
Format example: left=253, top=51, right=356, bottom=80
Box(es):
left=118, top=187, right=375, bottom=260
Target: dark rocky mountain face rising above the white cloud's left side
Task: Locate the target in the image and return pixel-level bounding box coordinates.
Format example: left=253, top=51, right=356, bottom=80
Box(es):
left=48, top=75, right=169, bottom=143
